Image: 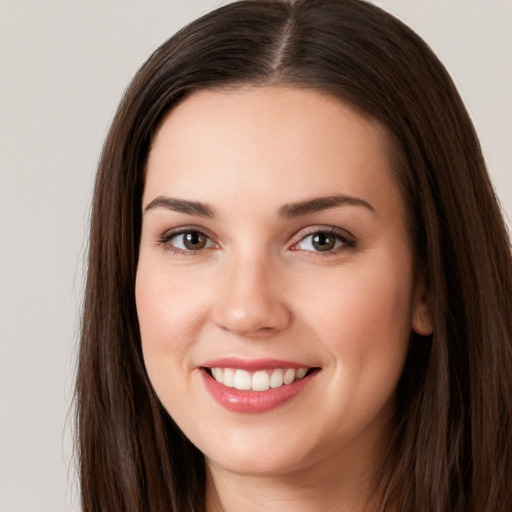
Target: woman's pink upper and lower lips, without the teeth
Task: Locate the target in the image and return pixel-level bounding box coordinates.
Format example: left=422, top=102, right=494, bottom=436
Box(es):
left=200, top=358, right=317, bottom=413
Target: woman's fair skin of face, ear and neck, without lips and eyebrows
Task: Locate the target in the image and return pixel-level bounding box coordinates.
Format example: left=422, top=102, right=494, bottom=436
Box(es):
left=136, top=87, right=432, bottom=512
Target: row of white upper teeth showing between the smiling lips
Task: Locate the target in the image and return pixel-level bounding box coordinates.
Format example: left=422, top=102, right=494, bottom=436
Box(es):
left=203, top=367, right=319, bottom=391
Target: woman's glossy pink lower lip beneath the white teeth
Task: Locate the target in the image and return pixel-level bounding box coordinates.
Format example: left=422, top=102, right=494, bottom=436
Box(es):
left=201, top=370, right=316, bottom=413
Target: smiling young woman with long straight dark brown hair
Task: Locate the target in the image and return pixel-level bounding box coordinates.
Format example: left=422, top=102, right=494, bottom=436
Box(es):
left=77, top=0, right=512, bottom=512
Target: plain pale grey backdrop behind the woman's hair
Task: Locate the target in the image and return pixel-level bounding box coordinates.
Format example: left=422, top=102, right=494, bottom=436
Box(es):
left=0, top=0, right=512, bottom=512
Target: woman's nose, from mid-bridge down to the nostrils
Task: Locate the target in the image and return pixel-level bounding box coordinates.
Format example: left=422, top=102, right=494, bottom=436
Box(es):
left=212, top=253, right=291, bottom=338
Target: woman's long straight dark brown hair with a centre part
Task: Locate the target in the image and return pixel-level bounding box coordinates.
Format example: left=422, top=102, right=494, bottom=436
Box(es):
left=76, top=0, right=512, bottom=512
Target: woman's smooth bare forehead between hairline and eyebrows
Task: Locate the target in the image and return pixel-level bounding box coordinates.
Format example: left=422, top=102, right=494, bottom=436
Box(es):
left=144, top=87, right=404, bottom=216
